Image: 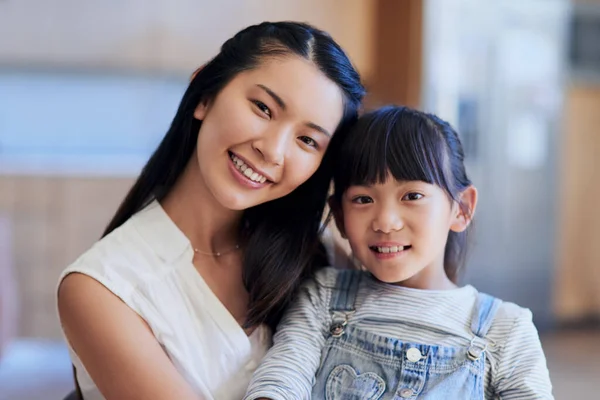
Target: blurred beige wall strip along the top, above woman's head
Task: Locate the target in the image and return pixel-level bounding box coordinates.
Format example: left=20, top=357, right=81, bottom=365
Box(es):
left=0, top=0, right=373, bottom=76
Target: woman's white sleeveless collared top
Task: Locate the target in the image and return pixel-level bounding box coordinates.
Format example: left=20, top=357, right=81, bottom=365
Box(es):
left=60, top=201, right=271, bottom=400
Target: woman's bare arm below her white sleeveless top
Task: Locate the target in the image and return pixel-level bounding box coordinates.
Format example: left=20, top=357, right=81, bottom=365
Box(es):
left=58, top=273, right=199, bottom=400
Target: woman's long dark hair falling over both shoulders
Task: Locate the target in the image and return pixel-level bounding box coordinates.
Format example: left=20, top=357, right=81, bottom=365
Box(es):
left=104, top=22, right=365, bottom=326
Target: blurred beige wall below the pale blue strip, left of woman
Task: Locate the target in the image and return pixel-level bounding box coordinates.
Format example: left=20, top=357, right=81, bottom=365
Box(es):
left=0, top=176, right=132, bottom=338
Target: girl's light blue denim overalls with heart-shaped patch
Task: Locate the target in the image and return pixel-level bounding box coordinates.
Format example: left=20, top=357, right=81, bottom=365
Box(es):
left=312, top=271, right=501, bottom=400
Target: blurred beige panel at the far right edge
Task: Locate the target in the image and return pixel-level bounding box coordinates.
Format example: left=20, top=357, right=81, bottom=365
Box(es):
left=556, top=85, right=600, bottom=320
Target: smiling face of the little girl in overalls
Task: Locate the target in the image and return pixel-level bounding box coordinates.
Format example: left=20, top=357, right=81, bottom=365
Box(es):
left=336, top=177, right=476, bottom=289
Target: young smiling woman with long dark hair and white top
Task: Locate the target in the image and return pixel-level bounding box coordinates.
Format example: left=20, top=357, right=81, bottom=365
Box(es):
left=58, top=22, right=364, bottom=400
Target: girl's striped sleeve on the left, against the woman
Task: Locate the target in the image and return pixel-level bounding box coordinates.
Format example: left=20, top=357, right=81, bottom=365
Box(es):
left=244, top=269, right=335, bottom=400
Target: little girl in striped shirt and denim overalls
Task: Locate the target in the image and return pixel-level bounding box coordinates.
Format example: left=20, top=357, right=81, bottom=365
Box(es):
left=245, top=107, right=553, bottom=400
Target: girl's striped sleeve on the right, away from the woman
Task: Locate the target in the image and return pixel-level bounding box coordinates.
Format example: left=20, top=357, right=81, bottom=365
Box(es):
left=492, top=309, right=554, bottom=400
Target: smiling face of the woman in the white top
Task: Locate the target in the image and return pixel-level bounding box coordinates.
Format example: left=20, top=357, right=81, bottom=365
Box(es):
left=194, top=56, right=344, bottom=210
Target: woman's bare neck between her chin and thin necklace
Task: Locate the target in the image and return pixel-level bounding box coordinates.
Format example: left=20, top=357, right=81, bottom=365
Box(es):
left=161, top=157, right=243, bottom=253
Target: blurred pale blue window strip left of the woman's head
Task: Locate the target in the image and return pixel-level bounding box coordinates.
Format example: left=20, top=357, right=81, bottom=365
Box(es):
left=0, top=70, right=187, bottom=176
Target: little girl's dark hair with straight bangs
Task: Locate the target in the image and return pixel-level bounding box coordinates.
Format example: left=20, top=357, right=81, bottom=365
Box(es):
left=333, top=106, right=471, bottom=282
